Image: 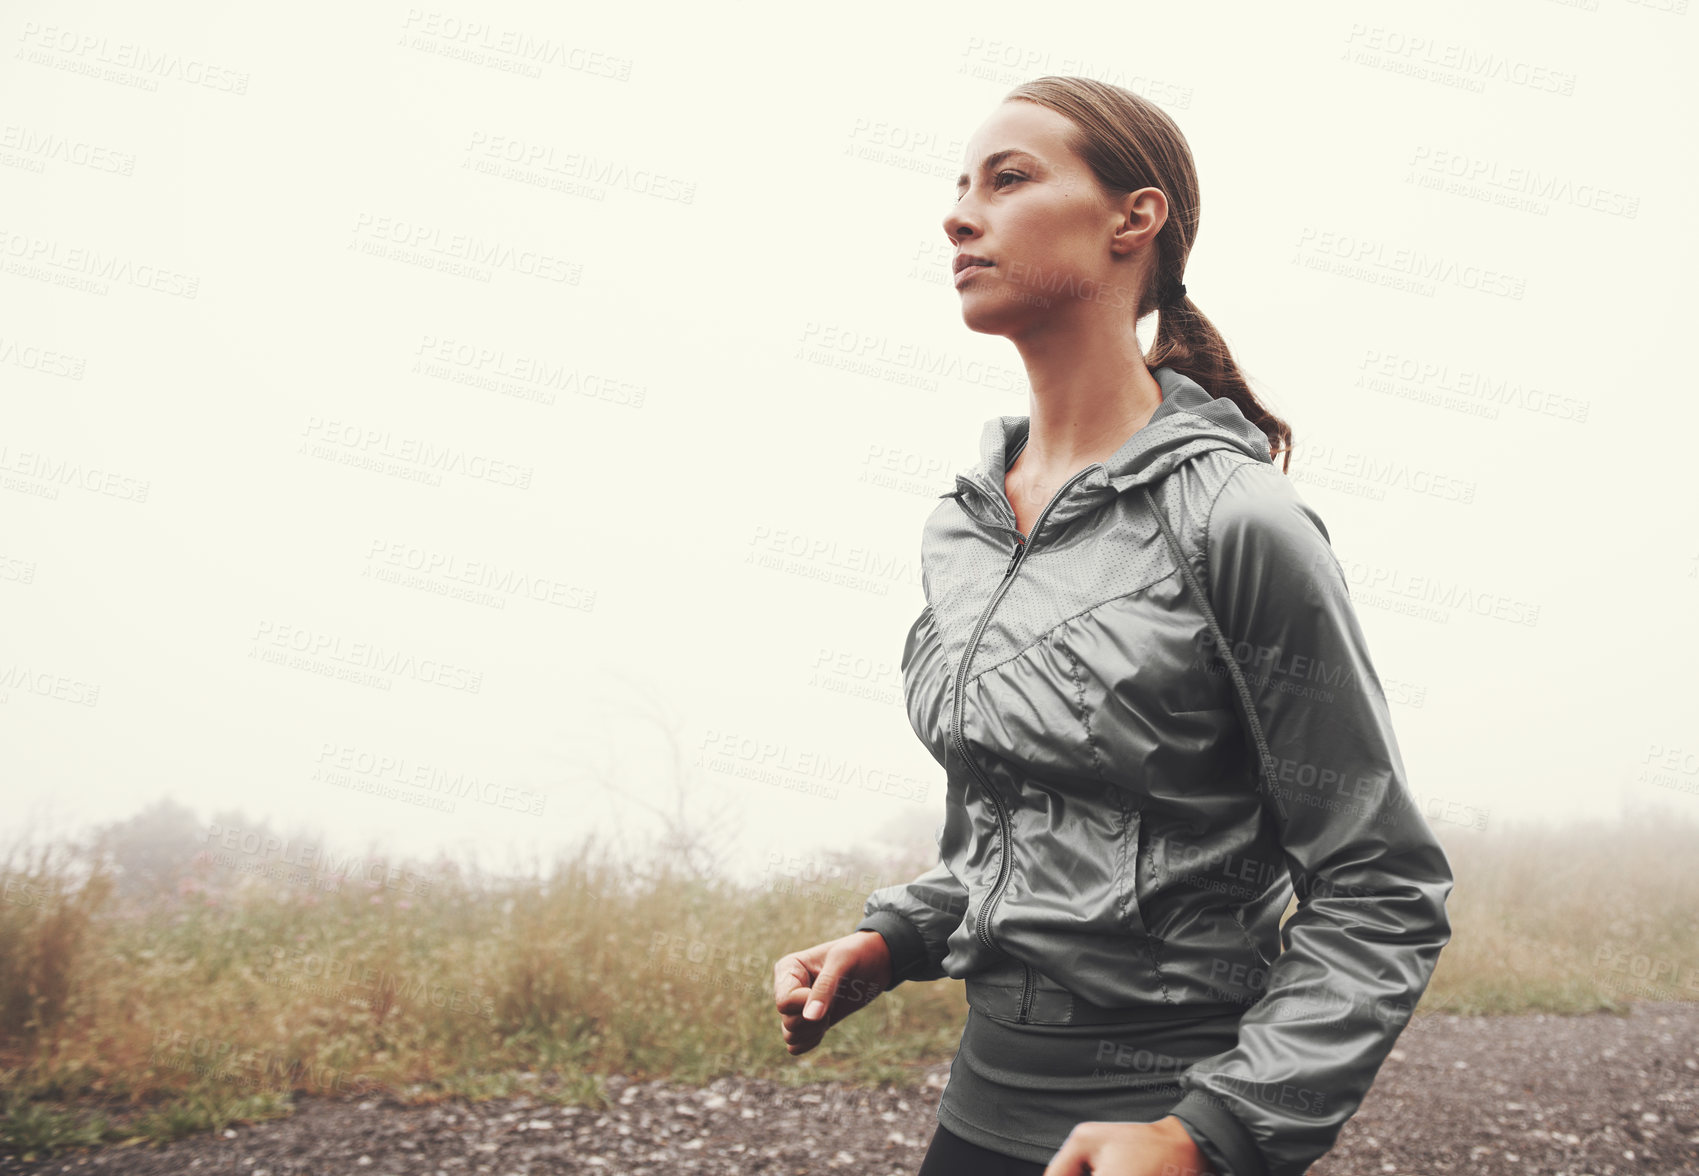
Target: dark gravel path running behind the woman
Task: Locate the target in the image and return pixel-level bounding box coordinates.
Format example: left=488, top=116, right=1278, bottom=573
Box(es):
left=0, top=1003, right=1699, bottom=1176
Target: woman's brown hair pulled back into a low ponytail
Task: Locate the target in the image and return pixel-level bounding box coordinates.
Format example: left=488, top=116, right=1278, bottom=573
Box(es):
left=1004, top=75, right=1291, bottom=471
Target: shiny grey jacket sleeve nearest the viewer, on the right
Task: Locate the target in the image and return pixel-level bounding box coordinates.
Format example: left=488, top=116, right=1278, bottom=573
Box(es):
left=1172, top=462, right=1453, bottom=1176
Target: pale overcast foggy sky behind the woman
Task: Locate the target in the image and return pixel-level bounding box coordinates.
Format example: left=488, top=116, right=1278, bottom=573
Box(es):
left=0, top=0, right=1699, bottom=872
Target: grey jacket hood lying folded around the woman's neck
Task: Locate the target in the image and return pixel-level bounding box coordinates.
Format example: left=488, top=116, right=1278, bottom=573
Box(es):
left=940, top=367, right=1274, bottom=523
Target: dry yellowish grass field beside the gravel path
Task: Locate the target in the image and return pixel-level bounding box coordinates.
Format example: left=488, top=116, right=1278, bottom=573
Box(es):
left=0, top=798, right=1699, bottom=1154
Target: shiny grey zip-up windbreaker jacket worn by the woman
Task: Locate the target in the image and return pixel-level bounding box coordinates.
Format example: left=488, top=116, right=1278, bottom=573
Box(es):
left=856, top=367, right=1453, bottom=1176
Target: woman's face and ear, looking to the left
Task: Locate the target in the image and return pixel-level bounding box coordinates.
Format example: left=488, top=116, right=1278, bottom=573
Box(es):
left=945, top=100, right=1167, bottom=335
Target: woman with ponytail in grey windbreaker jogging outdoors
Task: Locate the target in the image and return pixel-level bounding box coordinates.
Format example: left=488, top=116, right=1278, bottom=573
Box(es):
left=775, top=76, right=1451, bottom=1176
